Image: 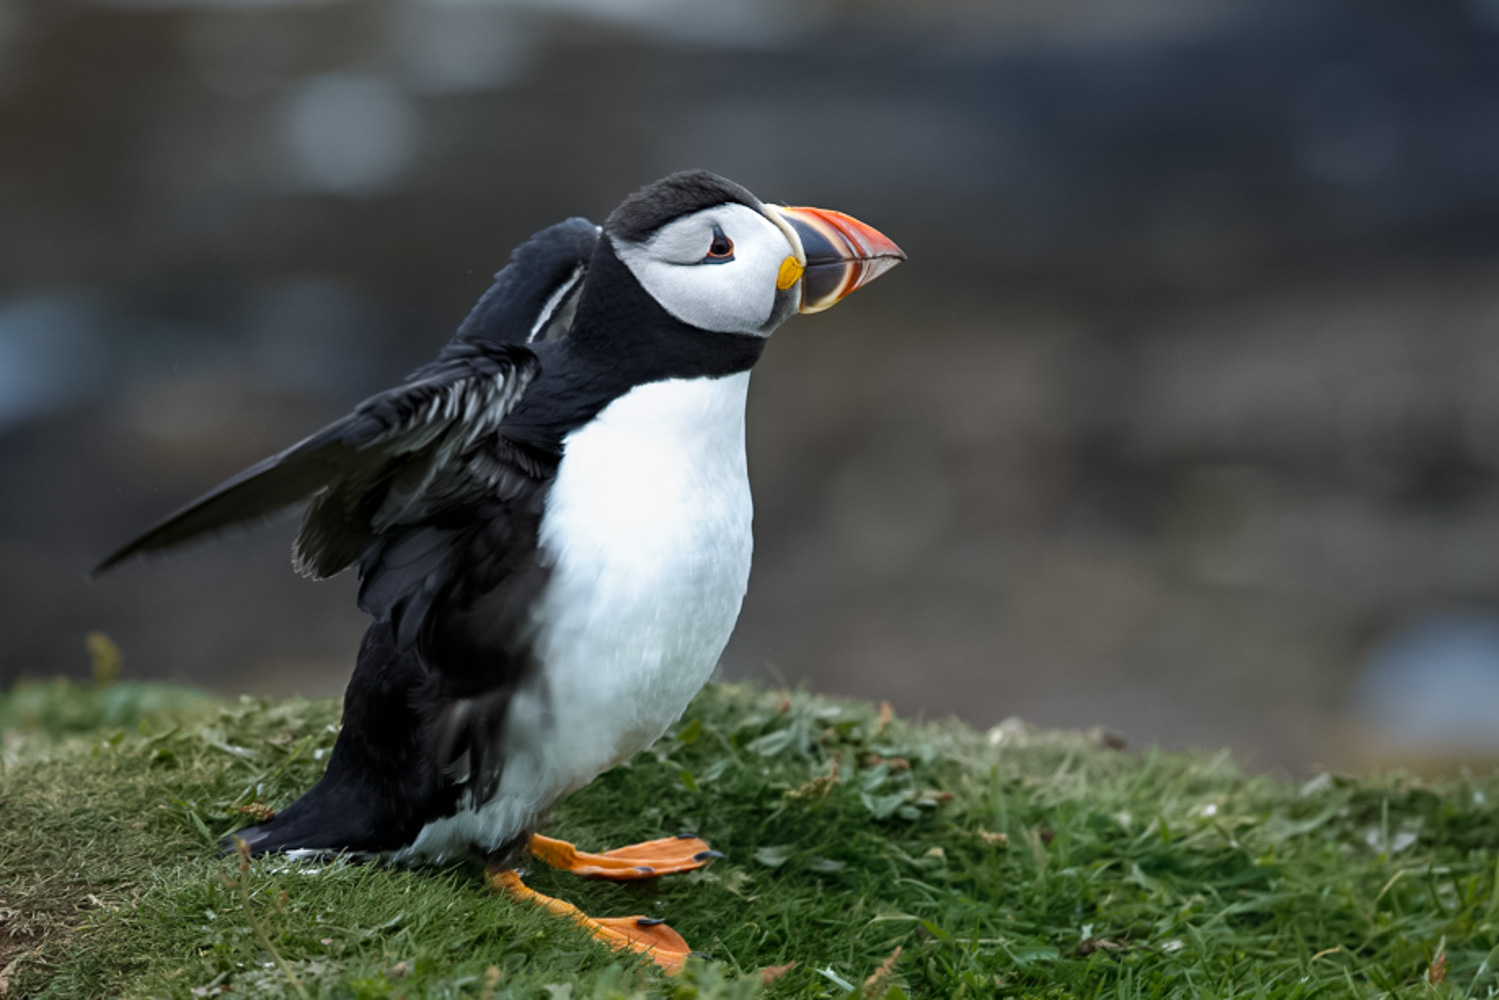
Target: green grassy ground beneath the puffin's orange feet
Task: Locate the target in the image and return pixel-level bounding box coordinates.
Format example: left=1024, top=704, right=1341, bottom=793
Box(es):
left=0, top=685, right=1499, bottom=1000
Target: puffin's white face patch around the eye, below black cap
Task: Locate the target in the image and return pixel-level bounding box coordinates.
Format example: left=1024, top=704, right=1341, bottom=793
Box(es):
left=615, top=204, right=800, bottom=336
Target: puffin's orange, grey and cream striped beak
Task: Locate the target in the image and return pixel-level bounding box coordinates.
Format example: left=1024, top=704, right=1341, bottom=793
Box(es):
left=767, top=205, right=905, bottom=312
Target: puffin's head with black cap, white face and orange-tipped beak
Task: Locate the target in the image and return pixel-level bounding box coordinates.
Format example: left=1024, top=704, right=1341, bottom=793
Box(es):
left=604, top=171, right=905, bottom=337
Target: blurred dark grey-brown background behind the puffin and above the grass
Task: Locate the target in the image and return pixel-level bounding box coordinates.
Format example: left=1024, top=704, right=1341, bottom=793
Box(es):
left=0, top=0, right=1499, bottom=774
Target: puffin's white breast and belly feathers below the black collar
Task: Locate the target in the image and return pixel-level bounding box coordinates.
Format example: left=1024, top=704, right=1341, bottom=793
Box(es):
left=402, top=372, right=752, bottom=859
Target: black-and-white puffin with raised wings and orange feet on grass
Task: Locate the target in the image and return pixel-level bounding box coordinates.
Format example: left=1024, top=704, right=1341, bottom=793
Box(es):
left=94, top=169, right=905, bottom=973
